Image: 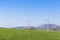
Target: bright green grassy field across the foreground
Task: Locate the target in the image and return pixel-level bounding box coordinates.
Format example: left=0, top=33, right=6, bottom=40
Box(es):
left=0, top=28, right=60, bottom=40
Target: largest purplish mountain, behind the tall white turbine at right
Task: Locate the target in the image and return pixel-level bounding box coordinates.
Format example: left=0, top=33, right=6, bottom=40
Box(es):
left=36, top=24, right=59, bottom=30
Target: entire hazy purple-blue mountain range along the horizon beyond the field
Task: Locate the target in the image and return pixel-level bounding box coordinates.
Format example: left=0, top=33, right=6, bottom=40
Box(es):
left=15, top=24, right=60, bottom=30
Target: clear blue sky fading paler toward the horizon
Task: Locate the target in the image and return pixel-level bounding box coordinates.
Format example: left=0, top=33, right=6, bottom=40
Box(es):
left=0, top=0, right=60, bottom=27
